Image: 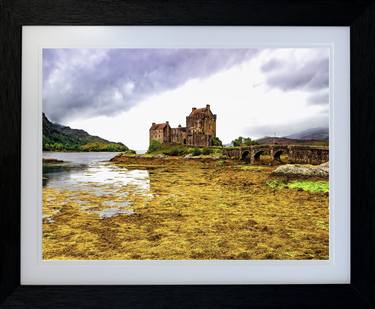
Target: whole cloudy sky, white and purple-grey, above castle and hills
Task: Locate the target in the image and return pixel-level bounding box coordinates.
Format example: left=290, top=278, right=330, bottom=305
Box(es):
left=43, top=48, right=329, bottom=150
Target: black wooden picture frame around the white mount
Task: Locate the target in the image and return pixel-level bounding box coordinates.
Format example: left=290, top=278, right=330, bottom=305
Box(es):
left=0, top=0, right=375, bottom=308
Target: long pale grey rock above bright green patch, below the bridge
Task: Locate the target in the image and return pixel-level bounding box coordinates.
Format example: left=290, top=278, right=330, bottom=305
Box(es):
left=272, top=162, right=329, bottom=178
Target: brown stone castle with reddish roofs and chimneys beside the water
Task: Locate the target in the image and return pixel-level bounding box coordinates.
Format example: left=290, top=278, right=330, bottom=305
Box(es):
left=150, top=105, right=216, bottom=147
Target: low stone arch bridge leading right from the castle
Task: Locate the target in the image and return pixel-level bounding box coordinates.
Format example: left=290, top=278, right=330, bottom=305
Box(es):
left=224, top=145, right=329, bottom=164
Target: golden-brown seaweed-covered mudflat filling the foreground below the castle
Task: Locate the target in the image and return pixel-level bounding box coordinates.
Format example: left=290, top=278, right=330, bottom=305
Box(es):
left=43, top=157, right=329, bottom=260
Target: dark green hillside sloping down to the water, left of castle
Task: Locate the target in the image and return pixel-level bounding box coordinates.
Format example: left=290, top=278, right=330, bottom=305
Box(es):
left=43, top=113, right=129, bottom=151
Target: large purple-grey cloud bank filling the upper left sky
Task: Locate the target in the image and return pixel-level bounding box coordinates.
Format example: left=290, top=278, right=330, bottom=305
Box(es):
left=43, top=49, right=258, bottom=122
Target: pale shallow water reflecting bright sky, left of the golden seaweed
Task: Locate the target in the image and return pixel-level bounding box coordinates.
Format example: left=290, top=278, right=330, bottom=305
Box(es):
left=43, top=153, right=150, bottom=219
